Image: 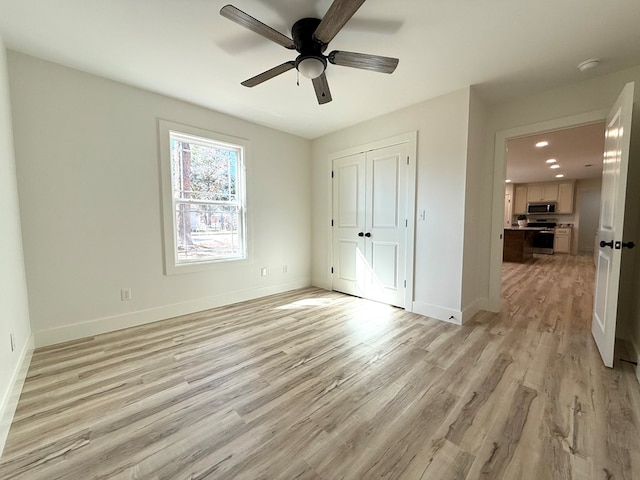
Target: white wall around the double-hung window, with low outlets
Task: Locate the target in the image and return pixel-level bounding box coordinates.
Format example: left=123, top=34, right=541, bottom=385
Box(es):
left=8, top=52, right=311, bottom=345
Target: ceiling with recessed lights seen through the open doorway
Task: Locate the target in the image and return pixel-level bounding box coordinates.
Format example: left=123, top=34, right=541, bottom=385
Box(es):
left=506, top=122, right=604, bottom=183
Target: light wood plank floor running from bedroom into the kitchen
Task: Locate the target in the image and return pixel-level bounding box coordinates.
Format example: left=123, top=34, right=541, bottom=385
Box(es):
left=0, top=255, right=640, bottom=480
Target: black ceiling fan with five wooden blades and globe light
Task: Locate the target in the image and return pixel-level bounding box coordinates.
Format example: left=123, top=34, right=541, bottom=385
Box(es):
left=220, top=0, right=399, bottom=105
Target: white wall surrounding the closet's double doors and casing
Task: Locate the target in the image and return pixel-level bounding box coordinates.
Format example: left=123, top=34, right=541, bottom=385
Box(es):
left=312, top=88, right=470, bottom=322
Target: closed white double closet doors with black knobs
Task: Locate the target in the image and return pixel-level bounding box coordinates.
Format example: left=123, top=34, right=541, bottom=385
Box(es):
left=333, top=144, right=408, bottom=307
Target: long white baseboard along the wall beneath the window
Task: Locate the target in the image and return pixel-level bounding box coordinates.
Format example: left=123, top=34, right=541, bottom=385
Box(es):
left=35, top=278, right=310, bottom=347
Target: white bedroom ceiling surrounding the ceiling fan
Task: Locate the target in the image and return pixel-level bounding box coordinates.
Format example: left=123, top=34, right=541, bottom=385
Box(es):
left=0, top=0, right=640, bottom=138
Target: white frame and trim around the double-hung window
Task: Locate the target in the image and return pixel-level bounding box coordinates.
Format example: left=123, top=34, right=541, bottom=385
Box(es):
left=158, top=119, right=249, bottom=275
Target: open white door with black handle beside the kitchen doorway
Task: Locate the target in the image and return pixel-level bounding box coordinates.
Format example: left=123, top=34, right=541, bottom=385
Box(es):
left=591, top=83, right=634, bottom=367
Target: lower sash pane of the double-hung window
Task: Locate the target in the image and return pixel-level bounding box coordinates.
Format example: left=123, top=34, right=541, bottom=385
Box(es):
left=175, top=203, right=243, bottom=263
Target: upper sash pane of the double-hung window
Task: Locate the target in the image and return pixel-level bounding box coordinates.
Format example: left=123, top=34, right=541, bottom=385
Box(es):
left=171, top=135, right=239, bottom=203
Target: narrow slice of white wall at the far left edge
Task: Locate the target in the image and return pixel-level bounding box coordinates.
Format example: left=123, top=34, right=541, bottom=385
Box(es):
left=0, top=38, right=33, bottom=454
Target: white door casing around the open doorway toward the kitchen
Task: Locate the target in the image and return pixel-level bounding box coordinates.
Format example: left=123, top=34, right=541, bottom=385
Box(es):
left=488, top=108, right=609, bottom=312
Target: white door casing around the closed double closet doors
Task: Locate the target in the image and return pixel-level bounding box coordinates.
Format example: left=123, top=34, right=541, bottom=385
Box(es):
left=327, top=130, right=418, bottom=312
